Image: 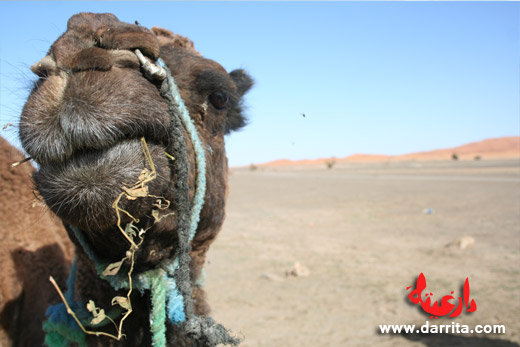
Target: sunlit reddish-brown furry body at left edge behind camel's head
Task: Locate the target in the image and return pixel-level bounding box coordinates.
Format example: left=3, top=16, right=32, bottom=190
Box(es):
left=0, top=137, right=73, bottom=346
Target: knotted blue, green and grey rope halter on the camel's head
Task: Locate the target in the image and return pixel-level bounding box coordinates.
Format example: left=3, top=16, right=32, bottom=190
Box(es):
left=44, top=50, right=240, bottom=347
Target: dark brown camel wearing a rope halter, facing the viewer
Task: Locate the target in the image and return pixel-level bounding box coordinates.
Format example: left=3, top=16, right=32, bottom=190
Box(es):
left=0, top=13, right=253, bottom=346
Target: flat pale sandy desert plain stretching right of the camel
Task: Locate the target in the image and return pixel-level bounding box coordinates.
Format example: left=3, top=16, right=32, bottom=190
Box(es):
left=205, top=159, right=520, bottom=346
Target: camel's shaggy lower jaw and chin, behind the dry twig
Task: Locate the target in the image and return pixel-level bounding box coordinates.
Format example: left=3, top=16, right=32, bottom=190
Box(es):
left=34, top=140, right=185, bottom=263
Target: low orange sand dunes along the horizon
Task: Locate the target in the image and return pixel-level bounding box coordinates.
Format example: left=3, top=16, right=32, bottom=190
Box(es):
left=260, top=136, right=520, bottom=166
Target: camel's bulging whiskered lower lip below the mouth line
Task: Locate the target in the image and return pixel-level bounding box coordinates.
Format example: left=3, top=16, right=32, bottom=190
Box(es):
left=34, top=139, right=174, bottom=237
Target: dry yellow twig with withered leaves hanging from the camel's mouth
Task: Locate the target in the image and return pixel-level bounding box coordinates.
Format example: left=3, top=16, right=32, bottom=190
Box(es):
left=49, top=137, right=174, bottom=341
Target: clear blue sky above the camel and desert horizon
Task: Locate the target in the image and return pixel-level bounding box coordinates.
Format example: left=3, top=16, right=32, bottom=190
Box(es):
left=0, top=1, right=520, bottom=166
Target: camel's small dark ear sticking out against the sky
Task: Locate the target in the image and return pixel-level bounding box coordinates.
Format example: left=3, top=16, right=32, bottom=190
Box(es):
left=226, top=70, right=254, bottom=134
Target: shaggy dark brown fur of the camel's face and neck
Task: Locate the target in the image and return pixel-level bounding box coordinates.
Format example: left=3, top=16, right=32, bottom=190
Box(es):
left=2, top=13, right=252, bottom=346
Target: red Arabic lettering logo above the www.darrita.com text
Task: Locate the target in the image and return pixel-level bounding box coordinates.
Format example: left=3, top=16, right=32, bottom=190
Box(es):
left=406, top=273, right=477, bottom=319
